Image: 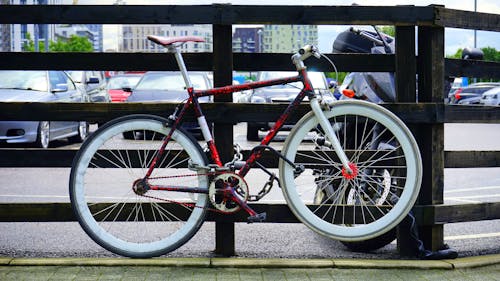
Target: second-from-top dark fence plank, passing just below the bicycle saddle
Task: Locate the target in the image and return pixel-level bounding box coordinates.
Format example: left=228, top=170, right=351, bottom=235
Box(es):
left=0, top=50, right=394, bottom=72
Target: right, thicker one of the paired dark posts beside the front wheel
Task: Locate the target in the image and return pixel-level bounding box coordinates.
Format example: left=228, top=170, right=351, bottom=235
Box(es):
left=417, top=26, right=444, bottom=251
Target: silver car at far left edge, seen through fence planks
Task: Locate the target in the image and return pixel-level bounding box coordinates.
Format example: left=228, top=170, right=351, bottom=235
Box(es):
left=0, top=70, right=89, bottom=148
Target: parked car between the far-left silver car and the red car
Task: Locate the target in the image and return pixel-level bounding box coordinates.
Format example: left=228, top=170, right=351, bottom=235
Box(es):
left=67, top=70, right=111, bottom=102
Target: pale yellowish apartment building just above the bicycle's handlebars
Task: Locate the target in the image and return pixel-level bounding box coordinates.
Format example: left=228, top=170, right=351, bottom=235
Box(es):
left=263, top=25, right=318, bottom=53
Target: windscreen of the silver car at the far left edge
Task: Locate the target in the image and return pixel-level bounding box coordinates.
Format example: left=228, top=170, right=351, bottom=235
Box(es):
left=0, top=70, right=48, bottom=92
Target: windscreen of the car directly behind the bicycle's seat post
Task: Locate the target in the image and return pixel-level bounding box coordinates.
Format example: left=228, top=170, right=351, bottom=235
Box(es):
left=135, top=72, right=208, bottom=91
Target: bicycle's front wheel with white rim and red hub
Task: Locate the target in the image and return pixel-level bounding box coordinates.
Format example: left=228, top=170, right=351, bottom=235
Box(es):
left=279, top=100, right=422, bottom=242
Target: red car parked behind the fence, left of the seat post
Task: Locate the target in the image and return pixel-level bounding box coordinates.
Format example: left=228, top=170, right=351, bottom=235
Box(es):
left=106, top=73, right=142, bottom=102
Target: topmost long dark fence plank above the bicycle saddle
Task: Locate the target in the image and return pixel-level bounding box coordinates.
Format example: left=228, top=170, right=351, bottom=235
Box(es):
left=0, top=4, right=435, bottom=25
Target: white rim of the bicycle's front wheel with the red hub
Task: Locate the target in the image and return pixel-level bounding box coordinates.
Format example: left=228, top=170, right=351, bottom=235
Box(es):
left=280, top=101, right=422, bottom=241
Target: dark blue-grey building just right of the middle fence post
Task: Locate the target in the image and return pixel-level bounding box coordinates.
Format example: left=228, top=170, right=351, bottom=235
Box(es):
left=233, top=27, right=263, bottom=53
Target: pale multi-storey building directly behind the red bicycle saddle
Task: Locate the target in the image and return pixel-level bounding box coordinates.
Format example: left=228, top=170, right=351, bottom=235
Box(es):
left=119, top=24, right=212, bottom=53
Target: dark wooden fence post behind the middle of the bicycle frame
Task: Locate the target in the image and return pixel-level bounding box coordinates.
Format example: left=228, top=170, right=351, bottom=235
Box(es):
left=212, top=24, right=235, bottom=256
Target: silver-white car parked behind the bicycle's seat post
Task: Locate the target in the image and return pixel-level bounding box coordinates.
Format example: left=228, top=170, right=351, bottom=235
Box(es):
left=124, top=71, right=212, bottom=139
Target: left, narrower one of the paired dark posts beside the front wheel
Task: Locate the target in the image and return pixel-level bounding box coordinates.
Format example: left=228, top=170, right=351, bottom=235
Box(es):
left=394, top=26, right=417, bottom=257
